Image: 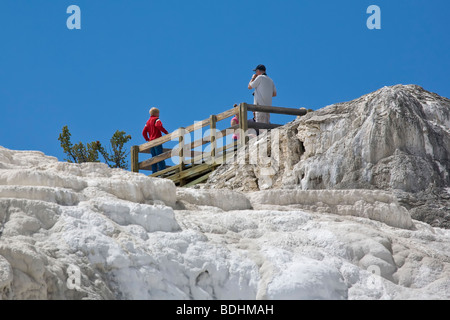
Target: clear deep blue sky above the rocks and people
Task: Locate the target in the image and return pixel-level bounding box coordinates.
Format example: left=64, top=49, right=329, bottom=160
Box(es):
left=0, top=0, right=450, bottom=168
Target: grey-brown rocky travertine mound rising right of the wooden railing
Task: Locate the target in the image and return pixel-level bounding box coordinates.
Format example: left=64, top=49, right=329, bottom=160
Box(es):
left=205, top=85, right=450, bottom=228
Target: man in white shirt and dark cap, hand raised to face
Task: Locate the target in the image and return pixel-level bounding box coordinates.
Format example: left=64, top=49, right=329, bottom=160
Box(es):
left=248, top=64, right=277, bottom=123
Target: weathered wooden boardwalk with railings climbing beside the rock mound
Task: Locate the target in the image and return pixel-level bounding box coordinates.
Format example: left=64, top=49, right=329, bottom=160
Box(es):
left=131, top=103, right=307, bottom=187
